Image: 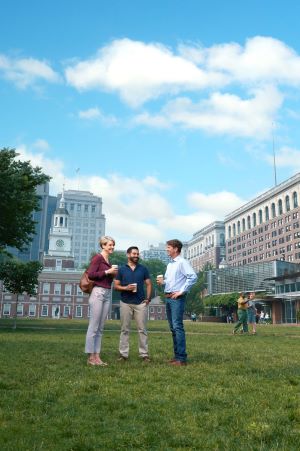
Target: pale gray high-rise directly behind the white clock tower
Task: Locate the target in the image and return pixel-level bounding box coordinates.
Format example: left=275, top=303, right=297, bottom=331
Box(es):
left=58, top=190, right=105, bottom=268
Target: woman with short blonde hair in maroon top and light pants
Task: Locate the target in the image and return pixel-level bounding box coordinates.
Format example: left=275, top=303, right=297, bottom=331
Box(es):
left=85, top=236, right=118, bottom=366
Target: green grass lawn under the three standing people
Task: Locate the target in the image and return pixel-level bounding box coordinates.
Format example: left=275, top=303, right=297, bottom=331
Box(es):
left=0, top=319, right=300, bottom=451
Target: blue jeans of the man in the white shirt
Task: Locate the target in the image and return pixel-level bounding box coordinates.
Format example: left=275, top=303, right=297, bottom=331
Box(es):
left=166, top=296, right=187, bottom=362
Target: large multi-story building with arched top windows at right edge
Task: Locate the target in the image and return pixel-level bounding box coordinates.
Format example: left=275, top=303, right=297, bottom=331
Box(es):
left=225, top=173, right=300, bottom=266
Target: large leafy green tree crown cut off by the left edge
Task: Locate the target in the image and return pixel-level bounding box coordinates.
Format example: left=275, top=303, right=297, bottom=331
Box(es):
left=0, top=148, right=50, bottom=254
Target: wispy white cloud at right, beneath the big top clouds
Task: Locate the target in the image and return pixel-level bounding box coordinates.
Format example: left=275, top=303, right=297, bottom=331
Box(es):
left=134, top=86, right=283, bottom=139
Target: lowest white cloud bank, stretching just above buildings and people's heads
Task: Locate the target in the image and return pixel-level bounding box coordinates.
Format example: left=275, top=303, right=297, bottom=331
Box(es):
left=16, top=145, right=244, bottom=250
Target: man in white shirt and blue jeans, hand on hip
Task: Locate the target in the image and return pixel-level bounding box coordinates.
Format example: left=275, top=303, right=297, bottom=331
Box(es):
left=157, top=239, right=197, bottom=366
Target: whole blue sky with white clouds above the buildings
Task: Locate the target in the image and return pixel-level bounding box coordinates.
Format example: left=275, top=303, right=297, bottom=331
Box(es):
left=0, top=0, right=300, bottom=249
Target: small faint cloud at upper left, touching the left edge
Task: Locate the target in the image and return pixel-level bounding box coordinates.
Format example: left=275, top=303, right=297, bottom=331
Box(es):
left=0, top=54, right=60, bottom=89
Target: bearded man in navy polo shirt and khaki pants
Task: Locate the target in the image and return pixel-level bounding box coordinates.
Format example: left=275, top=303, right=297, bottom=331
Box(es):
left=114, top=246, right=152, bottom=362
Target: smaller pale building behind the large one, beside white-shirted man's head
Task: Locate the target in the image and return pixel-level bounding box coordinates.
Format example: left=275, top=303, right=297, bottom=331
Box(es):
left=185, top=221, right=225, bottom=272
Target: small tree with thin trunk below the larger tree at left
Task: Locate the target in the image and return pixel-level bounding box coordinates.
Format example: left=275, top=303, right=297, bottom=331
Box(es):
left=0, top=259, right=43, bottom=329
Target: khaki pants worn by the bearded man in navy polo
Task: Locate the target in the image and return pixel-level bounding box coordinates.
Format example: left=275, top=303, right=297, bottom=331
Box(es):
left=119, top=301, right=148, bottom=358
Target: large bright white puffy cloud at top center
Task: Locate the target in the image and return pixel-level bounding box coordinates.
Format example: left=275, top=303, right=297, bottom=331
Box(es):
left=65, top=39, right=224, bottom=107
